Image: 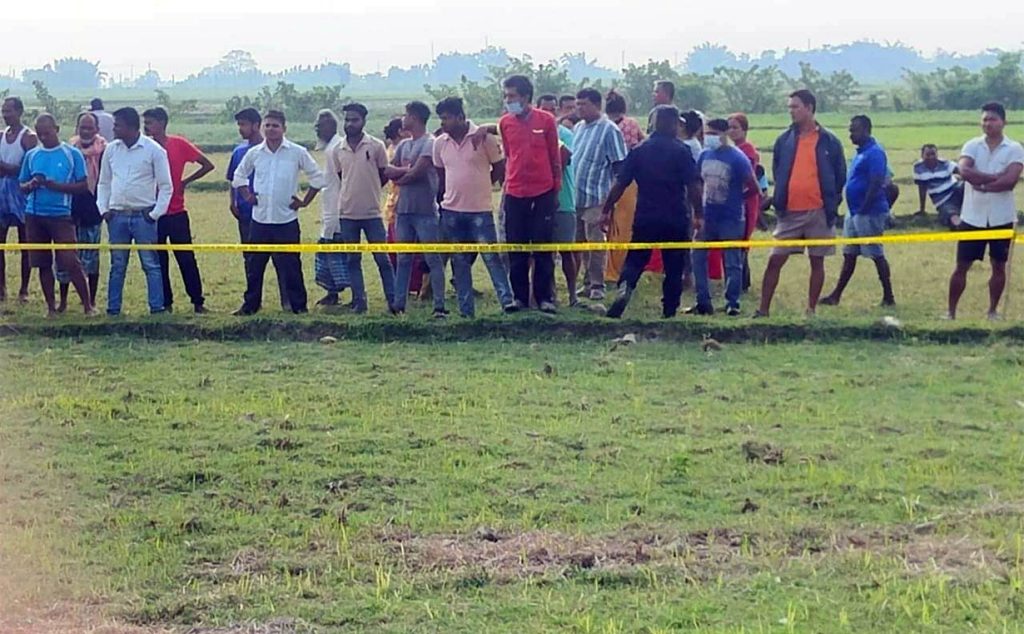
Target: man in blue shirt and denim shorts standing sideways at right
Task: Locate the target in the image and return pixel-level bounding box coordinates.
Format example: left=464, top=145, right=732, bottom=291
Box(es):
left=821, top=115, right=896, bottom=306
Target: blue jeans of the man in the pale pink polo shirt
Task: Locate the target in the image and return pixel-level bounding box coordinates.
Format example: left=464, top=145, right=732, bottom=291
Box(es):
left=441, top=211, right=513, bottom=316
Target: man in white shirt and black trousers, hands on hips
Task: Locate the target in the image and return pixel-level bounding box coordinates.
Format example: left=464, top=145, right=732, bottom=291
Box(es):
left=231, top=111, right=324, bottom=315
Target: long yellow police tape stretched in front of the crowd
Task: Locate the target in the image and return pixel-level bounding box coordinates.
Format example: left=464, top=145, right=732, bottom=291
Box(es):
left=0, top=229, right=1024, bottom=253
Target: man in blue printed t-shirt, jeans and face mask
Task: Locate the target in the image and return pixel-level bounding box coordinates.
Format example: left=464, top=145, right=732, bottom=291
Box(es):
left=686, top=119, right=760, bottom=316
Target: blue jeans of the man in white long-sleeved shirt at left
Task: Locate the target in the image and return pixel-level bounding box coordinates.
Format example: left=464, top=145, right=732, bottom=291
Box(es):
left=106, top=211, right=164, bottom=314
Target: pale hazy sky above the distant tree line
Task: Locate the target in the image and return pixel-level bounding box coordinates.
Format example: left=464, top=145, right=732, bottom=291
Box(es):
left=6, top=0, right=1024, bottom=80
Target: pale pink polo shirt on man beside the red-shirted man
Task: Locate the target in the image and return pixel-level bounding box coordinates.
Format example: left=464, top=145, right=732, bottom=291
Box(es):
left=433, top=125, right=504, bottom=212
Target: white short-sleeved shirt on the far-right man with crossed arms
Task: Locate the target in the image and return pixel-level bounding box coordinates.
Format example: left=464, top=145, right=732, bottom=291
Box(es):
left=961, top=136, right=1024, bottom=227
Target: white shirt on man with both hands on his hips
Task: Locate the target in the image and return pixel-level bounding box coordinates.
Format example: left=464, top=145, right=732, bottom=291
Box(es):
left=231, top=138, right=324, bottom=224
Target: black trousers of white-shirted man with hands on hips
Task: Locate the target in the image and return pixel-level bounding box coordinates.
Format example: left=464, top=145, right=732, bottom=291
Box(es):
left=242, top=220, right=306, bottom=312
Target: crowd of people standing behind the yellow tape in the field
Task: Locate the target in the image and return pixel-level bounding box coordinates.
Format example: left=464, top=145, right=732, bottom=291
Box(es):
left=0, top=76, right=1024, bottom=320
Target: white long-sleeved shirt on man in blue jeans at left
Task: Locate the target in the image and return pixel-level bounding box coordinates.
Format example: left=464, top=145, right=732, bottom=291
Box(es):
left=96, top=134, right=174, bottom=220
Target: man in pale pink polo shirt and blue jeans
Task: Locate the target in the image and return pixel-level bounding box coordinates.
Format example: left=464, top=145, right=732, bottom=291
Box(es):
left=433, top=97, right=518, bottom=318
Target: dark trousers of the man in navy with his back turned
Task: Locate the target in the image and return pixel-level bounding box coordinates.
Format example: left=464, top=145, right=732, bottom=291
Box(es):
left=618, top=219, right=690, bottom=314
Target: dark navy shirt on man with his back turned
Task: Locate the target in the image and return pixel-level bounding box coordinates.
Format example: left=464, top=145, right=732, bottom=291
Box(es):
left=617, top=132, right=700, bottom=226
